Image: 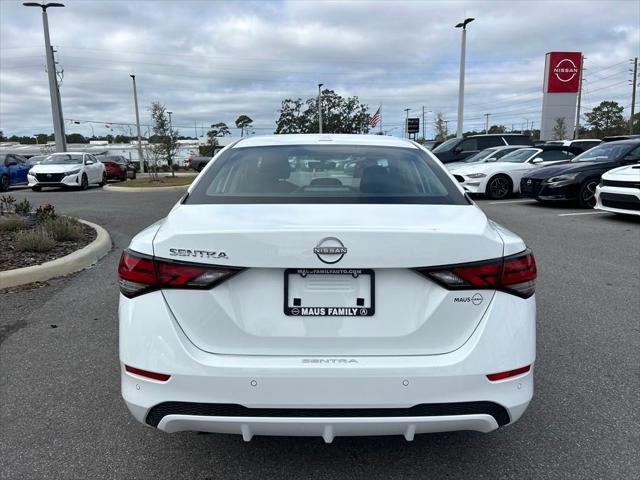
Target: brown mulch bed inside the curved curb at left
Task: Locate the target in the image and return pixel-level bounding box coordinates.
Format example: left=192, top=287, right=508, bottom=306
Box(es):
left=0, top=223, right=97, bottom=272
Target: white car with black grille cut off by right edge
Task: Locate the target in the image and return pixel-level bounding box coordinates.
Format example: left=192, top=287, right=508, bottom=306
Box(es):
left=594, top=165, right=640, bottom=215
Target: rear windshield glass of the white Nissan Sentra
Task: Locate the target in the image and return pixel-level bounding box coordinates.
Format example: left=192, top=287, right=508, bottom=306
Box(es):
left=185, top=145, right=469, bottom=205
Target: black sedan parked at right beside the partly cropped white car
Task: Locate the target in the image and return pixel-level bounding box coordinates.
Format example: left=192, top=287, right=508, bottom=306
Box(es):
left=520, top=139, right=640, bottom=207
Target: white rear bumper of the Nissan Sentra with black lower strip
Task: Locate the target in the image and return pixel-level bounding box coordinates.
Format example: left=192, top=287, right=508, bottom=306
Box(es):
left=120, top=292, right=535, bottom=441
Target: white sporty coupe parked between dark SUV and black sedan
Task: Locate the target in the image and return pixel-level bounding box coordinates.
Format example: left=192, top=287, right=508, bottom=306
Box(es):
left=452, top=147, right=574, bottom=200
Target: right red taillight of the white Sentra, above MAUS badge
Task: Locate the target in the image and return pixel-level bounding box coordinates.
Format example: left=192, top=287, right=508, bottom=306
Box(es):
left=416, top=249, right=537, bottom=298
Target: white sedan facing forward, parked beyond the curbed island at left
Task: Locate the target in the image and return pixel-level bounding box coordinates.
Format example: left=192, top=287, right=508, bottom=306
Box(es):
left=27, top=152, right=107, bottom=192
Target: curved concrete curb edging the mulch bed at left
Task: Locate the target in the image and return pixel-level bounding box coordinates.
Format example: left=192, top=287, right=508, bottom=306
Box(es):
left=0, top=219, right=111, bottom=290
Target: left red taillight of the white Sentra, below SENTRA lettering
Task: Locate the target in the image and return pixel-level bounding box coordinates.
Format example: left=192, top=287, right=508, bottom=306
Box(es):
left=118, top=251, right=243, bottom=298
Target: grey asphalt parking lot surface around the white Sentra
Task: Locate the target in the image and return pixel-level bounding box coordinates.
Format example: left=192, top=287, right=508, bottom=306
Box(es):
left=0, top=188, right=640, bottom=480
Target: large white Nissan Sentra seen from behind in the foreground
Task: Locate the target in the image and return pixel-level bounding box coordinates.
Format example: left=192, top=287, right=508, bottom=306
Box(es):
left=118, top=135, right=536, bottom=442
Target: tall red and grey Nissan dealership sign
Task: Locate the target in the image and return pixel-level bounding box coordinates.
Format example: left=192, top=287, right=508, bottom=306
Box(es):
left=540, top=52, right=582, bottom=140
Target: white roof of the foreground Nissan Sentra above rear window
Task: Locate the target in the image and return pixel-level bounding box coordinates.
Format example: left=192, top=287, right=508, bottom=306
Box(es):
left=231, top=133, right=418, bottom=149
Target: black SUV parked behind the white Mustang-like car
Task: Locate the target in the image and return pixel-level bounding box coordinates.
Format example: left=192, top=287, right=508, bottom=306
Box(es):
left=432, top=133, right=533, bottom=163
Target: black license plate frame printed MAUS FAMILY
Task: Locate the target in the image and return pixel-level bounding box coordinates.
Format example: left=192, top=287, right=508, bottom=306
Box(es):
left=283, top=268, right=376, bottom=317
